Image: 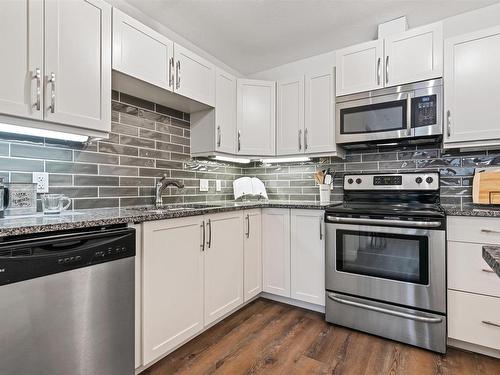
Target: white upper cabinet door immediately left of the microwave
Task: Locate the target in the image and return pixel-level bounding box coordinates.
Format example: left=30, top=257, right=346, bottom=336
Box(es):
left=304, top=68, right=336, bottom=154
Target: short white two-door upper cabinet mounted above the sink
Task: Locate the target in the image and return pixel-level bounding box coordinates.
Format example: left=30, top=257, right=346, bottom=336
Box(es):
left=113, top=8, right=215, bottom=107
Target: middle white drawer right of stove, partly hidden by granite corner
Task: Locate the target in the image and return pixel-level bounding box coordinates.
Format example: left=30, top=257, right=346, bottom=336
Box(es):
left=448, top=241, right=500, bottom=297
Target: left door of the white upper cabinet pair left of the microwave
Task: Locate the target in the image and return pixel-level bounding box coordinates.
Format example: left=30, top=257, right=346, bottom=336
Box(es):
left=276, top=76, right=305, bottom=155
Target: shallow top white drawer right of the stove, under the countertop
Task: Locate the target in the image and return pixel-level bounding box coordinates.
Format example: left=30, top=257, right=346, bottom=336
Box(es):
left=448, top=216, right=500, bottom=244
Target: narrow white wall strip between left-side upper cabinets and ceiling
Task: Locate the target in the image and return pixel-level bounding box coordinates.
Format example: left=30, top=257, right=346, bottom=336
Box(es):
left=106, top=0, right=243, bottom=77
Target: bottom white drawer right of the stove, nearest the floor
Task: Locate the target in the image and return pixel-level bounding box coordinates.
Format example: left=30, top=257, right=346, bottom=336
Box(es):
left=448, top=290, right=500, bottom=349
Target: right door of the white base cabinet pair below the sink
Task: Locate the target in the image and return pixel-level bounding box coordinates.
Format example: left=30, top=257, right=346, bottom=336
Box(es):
left=205, top=211, right=243, bottom=324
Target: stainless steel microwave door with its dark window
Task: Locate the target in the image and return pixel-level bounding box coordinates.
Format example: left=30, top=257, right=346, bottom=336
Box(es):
left=336, top=91, right=413, bottom=143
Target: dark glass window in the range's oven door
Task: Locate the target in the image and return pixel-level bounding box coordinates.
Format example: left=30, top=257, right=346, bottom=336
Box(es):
left=337, top=229, right=429, bottom=285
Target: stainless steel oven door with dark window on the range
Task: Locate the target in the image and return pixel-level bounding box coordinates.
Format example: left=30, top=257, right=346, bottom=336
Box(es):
left=326, top=223, right=446, bottom=313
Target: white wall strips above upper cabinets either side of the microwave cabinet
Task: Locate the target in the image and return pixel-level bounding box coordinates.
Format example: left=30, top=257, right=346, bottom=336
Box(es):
left=249, top=4, right=500, bottom=81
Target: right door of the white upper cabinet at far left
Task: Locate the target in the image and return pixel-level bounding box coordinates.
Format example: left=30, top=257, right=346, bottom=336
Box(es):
left=44, top=0, right=111, bottom=132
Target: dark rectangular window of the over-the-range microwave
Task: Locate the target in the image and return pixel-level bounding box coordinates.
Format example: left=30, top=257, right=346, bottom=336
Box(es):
left=340, top=100, right=406, bottom=134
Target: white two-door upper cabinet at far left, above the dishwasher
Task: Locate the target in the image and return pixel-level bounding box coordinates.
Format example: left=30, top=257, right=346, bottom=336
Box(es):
left=0, top=0, right=111, bottom=135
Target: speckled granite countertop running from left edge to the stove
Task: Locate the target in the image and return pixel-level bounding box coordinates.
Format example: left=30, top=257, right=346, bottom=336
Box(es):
left=0, top=201, right=334, bottom=237
